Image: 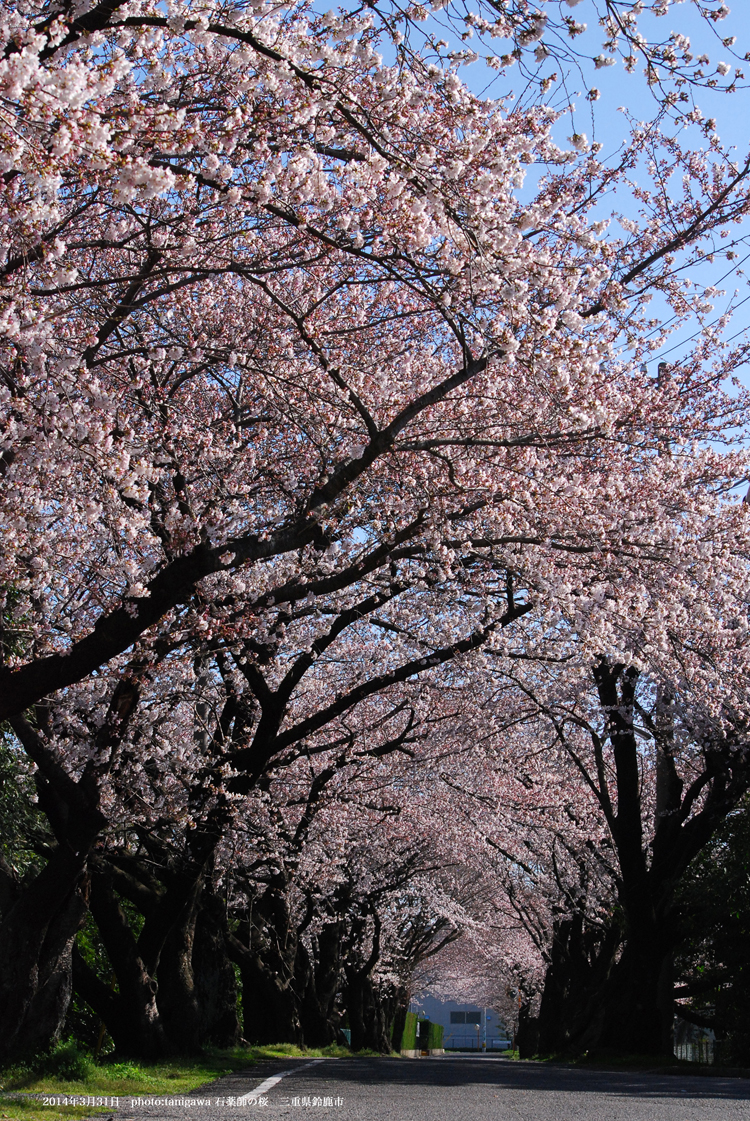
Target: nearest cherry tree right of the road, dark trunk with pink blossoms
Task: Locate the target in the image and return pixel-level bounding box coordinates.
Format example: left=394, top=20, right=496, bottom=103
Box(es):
left=419, top=627, right=750, bottom=1054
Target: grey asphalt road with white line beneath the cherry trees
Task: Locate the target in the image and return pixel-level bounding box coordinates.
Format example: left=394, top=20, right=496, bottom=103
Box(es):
left=117, top=1056, right=750, bottom=1121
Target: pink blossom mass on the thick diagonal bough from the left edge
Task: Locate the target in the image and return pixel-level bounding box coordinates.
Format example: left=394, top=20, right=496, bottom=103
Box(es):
left=2, top=0, right=746, bottom=715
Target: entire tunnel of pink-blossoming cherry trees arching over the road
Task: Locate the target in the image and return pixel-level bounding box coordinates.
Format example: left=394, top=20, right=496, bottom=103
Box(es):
left=0, top=0, right=750, bottom=1055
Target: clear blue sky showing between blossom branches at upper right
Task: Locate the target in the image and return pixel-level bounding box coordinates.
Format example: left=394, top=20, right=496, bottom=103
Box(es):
left=327, top=0, right=750, bottom=386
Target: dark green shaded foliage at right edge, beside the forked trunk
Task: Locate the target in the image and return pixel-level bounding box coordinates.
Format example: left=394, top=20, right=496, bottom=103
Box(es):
left=676, top=803, right=750, bottom=1066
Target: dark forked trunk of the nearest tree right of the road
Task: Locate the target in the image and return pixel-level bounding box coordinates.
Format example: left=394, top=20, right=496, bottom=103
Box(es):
left=529, top=661, right=750, bottom=1056
